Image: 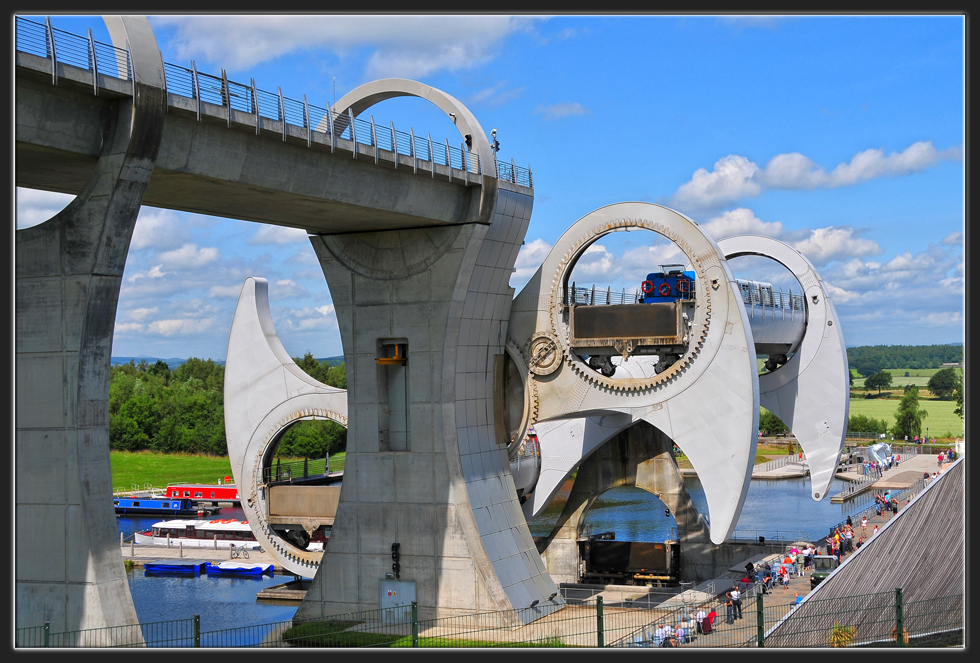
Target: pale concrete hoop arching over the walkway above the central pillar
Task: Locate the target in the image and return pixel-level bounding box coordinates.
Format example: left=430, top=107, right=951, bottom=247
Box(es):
left=315, top=78, right=497, bottom=224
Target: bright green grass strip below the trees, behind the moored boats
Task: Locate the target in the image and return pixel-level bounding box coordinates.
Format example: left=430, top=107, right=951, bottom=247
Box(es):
left=109, top=451, right=346, bottom=492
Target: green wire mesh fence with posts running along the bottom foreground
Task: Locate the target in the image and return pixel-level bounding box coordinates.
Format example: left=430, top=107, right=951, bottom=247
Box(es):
left=16, top=587, right=964, bottom=648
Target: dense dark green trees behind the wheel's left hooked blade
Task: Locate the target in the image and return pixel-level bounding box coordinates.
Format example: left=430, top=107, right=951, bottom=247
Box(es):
left=109, top=353, right=347, bottom=458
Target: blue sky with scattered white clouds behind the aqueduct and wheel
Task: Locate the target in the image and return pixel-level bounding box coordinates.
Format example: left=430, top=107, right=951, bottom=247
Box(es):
left=16, top=14, right=966, bottom=360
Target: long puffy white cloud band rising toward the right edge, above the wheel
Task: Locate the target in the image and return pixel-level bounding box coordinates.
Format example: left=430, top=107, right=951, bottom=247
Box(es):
left=668, top=141, right=963, bottom=210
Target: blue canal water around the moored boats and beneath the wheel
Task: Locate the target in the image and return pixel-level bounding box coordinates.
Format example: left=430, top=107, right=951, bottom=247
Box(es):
left=117, top=477, right=857, bottom=644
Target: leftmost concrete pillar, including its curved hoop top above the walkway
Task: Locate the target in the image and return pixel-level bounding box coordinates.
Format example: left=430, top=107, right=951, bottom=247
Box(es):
left=15, top=17, right=165, bottom=633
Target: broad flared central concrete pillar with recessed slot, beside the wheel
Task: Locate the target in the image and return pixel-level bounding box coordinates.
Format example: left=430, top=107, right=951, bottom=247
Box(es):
left=296, top=188, right=562, bottom=621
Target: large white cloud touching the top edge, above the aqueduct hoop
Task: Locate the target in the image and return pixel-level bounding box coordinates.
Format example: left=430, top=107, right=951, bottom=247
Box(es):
left=153, top=14, right=546, bottom=79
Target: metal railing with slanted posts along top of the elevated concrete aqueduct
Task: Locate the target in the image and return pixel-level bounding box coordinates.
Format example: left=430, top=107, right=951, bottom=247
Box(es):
left=16, top=16, right=534, bottom=188
